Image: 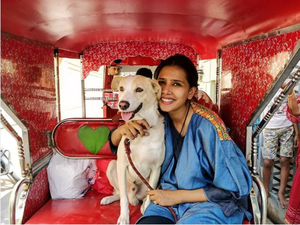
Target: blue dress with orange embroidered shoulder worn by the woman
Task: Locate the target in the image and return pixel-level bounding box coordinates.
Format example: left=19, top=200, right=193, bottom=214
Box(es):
left=138, top=103, right=252, bottom=224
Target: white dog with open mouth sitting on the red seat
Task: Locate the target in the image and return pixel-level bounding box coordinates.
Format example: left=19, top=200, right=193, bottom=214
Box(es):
left=101, top=75, right=165, bottom=224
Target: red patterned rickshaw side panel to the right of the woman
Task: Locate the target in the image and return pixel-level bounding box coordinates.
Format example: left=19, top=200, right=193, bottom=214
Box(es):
left=220, top=31, right=300, bottom=152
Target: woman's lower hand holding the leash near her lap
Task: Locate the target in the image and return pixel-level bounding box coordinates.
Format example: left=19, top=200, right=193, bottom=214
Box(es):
left=146, top=190, right=181, bottom=206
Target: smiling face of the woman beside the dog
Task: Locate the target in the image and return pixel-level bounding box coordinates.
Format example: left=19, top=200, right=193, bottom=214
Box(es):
left=158, top=65, right=195, bottom=113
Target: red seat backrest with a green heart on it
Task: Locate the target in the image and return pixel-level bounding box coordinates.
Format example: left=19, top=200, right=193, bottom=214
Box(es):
left=52, top=118, right=122, bottom=159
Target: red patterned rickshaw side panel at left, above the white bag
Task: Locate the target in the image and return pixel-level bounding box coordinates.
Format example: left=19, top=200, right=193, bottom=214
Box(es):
left=1, top=33, right=57, bottom=162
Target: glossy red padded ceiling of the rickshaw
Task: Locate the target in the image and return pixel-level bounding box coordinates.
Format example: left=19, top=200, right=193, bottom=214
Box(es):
left=1, top=0, right=300, bottom=56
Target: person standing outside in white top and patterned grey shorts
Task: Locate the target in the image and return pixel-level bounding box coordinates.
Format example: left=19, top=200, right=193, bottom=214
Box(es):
left=262, top=90, right=299, bottom=209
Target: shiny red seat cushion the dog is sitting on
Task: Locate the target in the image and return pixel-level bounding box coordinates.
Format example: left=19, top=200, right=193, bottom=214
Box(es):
left=26, top=189, right=141, bottom=224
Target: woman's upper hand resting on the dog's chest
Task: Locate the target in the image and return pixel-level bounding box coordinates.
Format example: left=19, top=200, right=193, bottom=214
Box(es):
left=116, top=120, right=150, bottom=140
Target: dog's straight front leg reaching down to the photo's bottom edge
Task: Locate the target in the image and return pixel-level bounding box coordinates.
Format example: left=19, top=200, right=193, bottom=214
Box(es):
left=117, top=157, right=129, bottom=224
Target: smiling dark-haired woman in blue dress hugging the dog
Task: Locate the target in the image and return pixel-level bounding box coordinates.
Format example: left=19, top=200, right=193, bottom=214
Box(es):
left=110, top=55, right=252, bottom=224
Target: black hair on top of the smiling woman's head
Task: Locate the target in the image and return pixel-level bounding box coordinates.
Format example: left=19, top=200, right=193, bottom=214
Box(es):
left=154, top=54, right=198, bottom=87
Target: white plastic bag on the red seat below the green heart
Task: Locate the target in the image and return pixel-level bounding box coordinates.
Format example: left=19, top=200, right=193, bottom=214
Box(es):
left=47, top=152, right=98, bottom=199
